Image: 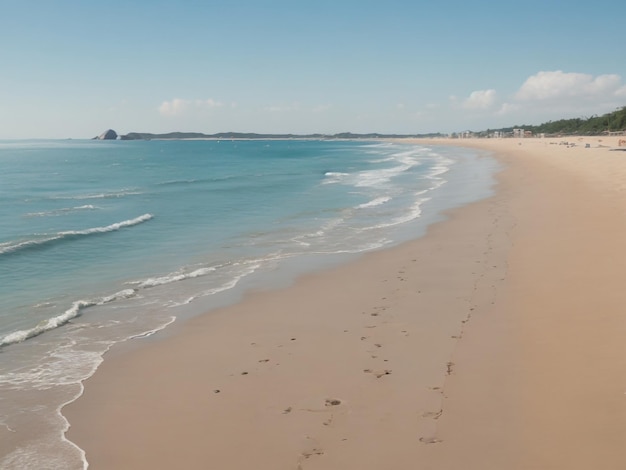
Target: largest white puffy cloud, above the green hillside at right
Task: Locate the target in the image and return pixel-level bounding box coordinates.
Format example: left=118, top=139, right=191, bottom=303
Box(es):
left=515, top=70, right=624, bottom=101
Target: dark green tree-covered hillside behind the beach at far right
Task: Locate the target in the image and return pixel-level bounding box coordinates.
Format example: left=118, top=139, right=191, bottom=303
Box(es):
left=477, top=106, right=626, bottom=137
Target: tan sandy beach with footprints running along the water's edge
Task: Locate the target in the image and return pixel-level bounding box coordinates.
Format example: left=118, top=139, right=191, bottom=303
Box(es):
left=63, top=138, right=626, bottom=470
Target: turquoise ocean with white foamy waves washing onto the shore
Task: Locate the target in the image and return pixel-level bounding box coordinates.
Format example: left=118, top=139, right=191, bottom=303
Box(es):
left=0, top=140, right=497, bottom=469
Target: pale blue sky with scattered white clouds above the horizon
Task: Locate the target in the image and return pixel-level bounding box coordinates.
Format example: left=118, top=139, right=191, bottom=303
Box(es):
left=0, top=0, right=626, bottom=139
